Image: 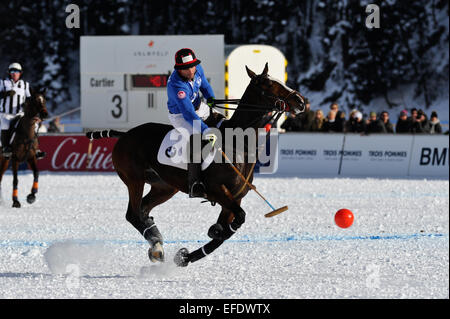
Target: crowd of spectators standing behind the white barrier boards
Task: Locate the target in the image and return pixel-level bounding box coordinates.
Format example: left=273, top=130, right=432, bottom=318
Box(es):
left=281, top=100, right=448, bottom=134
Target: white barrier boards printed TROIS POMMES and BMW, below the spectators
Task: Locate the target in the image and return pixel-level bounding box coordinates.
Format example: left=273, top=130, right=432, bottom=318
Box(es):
left=277, top=133, right=449, bottom=178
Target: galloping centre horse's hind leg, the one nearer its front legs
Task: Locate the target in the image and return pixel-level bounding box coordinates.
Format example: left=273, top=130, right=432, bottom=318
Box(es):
left=141, top=183, right=178, bottom=262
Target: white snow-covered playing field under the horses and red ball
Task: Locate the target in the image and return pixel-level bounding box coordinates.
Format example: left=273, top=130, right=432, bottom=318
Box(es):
left=0, top=172, right=449, bottom=299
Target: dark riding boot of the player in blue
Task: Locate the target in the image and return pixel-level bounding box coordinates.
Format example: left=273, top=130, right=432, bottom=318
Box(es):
left=188, top=134, right=206, bottom=198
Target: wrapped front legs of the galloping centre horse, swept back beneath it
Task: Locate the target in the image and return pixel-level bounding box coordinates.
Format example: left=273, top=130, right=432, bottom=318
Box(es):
left=175, top=186, right=245, bottom=267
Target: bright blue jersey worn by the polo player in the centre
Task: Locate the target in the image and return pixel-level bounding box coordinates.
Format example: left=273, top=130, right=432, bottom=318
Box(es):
left=167, top=64, right=214, bottom=133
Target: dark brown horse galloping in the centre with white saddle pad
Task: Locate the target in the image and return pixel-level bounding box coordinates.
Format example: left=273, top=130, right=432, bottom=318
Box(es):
left=87, top=64, right=304, bottom=266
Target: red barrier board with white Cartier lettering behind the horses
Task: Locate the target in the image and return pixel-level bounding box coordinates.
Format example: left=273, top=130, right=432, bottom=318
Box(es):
left=38, top=135, right=117, bottom=172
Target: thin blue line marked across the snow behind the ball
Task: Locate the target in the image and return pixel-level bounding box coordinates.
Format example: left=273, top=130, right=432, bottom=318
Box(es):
left=0, top=233, right=448, bottom=247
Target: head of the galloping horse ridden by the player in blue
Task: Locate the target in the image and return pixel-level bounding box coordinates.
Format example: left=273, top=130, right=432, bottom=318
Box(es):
left=245, top=63, right=305, bottom=114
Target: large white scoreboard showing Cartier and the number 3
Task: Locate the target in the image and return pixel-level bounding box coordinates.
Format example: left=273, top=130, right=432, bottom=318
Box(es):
left=80, top=35, right=225, bottom=129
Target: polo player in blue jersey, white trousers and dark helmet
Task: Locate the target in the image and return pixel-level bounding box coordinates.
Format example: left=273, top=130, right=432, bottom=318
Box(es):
left=167, top=48, right=217, bottom=197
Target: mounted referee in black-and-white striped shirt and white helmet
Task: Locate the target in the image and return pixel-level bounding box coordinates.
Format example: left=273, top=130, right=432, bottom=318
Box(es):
left=0, top=62, right=45, bottom=159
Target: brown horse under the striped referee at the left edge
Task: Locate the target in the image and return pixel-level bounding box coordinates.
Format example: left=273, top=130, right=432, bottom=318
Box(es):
left=0, top=90, right=48, bottom=208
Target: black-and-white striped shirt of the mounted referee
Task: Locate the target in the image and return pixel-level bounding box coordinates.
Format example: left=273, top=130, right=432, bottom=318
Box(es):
left=0, top=79, right=31, bottom=115
